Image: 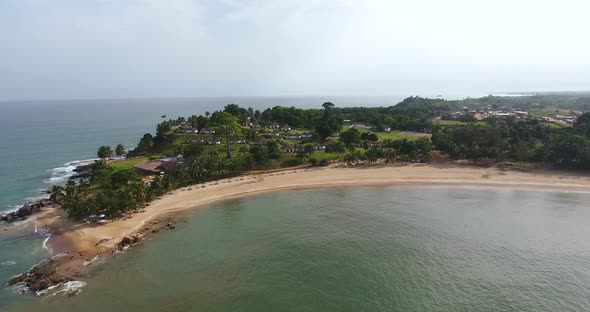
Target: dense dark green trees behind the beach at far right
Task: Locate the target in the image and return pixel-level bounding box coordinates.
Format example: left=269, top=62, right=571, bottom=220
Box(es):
left=432, top=114, right=590, bottom=168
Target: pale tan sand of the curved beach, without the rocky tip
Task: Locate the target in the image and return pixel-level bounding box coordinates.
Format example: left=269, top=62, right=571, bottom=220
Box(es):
left=37, top=165, right=590, bottom=258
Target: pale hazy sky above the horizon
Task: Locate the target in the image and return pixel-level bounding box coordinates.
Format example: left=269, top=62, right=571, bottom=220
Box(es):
left=0, top=0, right=590, bottom=101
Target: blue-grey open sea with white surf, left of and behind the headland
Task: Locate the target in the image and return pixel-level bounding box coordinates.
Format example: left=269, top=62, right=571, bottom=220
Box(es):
left=0, top=97, right=402, bottom=310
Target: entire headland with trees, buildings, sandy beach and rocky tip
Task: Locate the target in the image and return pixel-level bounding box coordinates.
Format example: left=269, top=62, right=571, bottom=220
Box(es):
left=9, top=96, right=590, bottom=291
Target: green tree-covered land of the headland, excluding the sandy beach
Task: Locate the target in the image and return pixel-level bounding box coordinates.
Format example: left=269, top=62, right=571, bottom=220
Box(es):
left=50, top=95, right=590, bottom=218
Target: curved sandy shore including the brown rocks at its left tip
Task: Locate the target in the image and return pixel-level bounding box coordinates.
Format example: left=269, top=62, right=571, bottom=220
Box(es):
left=9, top=164, right=590, bottom=290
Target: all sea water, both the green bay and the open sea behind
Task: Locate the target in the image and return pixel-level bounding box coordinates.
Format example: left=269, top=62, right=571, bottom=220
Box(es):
left=9, top=97, right=590, bottom=312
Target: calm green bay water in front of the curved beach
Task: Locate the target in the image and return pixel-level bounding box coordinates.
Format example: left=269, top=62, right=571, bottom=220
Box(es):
left=7, top=187, right=590, bottom=312
